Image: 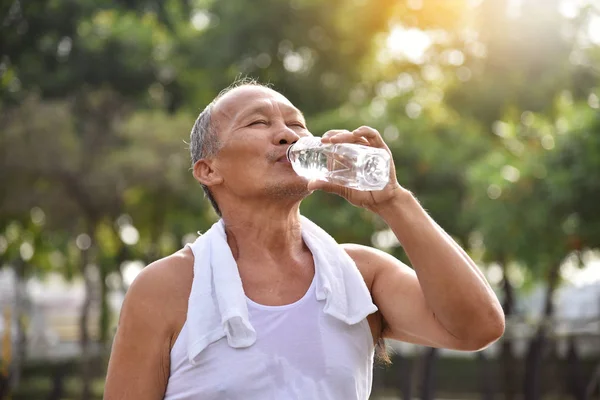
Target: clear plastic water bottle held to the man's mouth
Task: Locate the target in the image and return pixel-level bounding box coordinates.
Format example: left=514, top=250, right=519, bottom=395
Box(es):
left=287, top=136, right=390, bottom=190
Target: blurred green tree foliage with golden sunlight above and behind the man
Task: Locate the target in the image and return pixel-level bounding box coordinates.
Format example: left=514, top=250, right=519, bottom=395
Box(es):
left=0, top=0, right=600, bottom=396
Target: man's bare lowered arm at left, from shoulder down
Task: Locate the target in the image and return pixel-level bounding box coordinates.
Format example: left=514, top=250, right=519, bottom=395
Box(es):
left=104, top=260, right=182, bottom=400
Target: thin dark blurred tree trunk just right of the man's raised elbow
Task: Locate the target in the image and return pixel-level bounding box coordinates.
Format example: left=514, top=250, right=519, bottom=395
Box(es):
left=500, top=260, right=517, bottom=400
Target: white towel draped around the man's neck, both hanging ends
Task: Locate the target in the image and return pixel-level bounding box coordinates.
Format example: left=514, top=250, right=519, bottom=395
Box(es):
left=186, top=217, right=377, bottom=364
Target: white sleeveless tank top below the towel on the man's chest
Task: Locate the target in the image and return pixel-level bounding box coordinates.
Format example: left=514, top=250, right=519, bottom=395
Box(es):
left=165, top=279, right=374, bottom=400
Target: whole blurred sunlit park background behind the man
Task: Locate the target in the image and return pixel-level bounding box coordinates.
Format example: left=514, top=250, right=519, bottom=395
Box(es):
left=0, top=0, right=600, bottom=400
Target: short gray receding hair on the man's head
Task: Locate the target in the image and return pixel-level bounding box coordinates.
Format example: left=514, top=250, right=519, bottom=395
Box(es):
left=190, top=77, right=268, bottom=217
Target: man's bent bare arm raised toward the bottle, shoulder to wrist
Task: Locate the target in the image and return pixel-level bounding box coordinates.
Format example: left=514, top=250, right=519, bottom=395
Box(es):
left=345, top=190, right=504, bottom=350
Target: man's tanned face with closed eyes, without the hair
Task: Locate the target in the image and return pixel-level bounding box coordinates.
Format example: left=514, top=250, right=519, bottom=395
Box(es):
left=212, top=86, right=311, bottom=202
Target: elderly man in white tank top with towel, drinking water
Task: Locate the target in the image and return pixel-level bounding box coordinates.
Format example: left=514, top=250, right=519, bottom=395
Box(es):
left=105, top=79, right=504, bottom=400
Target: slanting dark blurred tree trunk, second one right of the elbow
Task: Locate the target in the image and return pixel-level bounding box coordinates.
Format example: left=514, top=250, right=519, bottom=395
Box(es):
left=523, top=263, right=560, bottom=400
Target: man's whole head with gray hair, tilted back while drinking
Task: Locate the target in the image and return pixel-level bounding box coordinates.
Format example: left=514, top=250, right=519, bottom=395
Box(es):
left=190, top=80, right=310, bottom=215
